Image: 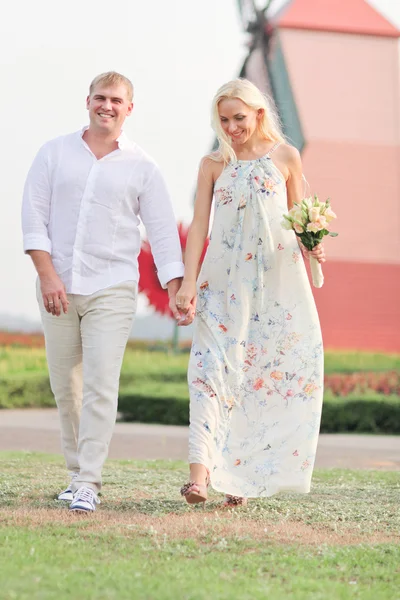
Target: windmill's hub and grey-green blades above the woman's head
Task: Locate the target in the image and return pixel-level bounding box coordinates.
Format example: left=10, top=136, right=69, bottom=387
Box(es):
left=237, top=0, right=305, bottom=152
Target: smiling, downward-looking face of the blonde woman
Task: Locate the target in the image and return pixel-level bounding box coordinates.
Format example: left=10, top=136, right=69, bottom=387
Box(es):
left=218, top=98, right=263, bottom=145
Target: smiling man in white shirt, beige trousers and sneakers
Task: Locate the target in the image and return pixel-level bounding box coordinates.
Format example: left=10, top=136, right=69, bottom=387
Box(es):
left=22, top=72, right=193, bottom=511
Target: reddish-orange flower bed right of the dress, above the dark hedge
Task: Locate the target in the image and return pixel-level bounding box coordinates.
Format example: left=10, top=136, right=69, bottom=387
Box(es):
left=325, top=371, right=400, bottom=396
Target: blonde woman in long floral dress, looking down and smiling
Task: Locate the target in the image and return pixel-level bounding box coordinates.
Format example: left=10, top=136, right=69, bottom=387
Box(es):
left=177, top=79, right=325, bottom=506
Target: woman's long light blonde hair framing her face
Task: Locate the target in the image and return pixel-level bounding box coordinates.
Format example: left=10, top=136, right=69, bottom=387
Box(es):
left=210, top=79, right=286, bottom=163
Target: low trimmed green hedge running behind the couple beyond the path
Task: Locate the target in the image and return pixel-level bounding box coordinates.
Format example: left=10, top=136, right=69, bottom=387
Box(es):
left=0, top=372, right=400, bottom=434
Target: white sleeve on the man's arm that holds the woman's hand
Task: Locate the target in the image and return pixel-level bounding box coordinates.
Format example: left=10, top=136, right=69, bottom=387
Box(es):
left=139, top=166, right=184, bottom=289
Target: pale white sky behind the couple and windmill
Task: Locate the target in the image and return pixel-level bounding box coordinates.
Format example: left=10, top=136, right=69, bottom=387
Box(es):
left=0, top=0, right=400, bottom=321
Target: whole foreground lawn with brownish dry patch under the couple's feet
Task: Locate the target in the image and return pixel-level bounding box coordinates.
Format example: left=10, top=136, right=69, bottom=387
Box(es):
left=0, top=453, right=400, bottom=600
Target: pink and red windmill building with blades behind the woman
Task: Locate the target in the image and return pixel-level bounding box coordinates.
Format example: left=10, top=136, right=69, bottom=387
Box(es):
left=236, top=0, right=400, bottom=352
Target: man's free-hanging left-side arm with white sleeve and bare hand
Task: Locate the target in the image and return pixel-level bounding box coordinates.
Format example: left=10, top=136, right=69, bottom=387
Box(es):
left=22, top=148, right=68, bottom=316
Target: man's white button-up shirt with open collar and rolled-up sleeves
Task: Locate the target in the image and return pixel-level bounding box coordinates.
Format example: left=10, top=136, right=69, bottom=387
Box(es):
left=22, top=130, right=184, bottom=295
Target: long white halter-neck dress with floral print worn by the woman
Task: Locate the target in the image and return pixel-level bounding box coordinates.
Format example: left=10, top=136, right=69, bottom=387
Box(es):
left=188, top=155, right=323, bottom=497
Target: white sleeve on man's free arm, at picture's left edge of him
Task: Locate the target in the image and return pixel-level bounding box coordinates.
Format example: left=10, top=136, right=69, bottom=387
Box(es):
left=22, top=147, right=51, bottom=254
